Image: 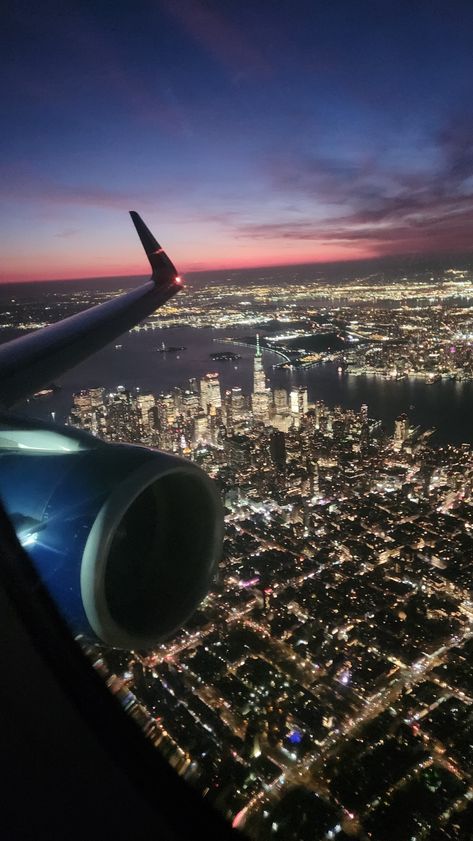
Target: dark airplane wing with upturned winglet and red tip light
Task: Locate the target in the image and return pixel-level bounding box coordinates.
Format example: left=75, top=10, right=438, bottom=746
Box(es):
left=0, top=210, right=182, bottom=409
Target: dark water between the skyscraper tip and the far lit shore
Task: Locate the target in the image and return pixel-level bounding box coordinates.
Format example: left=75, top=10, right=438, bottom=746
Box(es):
left=16, top=328, right=473, bottom=443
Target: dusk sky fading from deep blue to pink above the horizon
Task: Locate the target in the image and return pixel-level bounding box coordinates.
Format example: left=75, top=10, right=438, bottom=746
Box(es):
left=0, top=0, right=473, bottom=282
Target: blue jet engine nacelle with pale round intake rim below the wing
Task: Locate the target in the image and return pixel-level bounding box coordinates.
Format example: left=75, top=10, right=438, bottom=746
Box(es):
left=0, top=419, right=223, bottom=649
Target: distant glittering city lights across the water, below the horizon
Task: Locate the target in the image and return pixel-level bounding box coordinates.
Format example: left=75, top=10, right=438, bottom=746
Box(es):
left=6, top=267, right=473, bottom=383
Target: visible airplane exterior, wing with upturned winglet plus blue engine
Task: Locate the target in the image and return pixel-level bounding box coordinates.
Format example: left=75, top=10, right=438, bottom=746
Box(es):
left=0, top=211, right=223, bottom=649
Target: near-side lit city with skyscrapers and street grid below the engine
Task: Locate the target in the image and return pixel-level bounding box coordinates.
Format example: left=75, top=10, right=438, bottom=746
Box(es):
left=70, top=337, right=473, bottom=841
